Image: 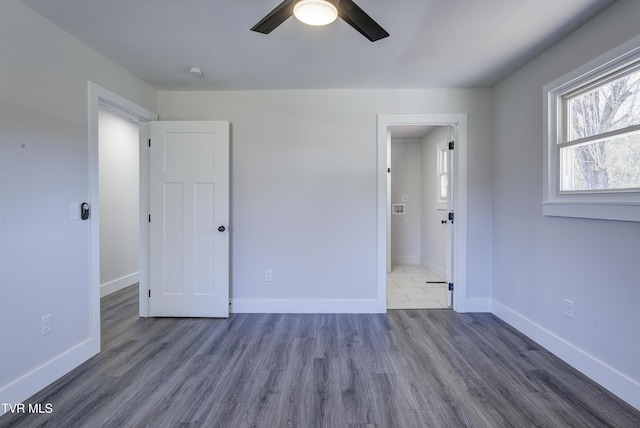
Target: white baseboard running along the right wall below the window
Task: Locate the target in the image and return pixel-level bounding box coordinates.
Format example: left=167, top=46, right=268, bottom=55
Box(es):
left=492, top=299, right=640, bottom=410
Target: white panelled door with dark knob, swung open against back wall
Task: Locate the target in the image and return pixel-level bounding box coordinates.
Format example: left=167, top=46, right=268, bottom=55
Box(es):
left=147, top=121, right=229, bottom=318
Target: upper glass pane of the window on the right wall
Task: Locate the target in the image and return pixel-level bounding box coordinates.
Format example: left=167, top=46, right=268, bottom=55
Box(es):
left=567, top=70, right=640, bottom=141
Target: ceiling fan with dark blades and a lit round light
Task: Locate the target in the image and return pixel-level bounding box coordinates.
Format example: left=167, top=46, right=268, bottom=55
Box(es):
left=251, top=0, right=389, bottom=42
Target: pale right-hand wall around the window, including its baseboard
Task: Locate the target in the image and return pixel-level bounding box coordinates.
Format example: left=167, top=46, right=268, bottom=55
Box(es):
left=493, top=0, right=640, bottom=408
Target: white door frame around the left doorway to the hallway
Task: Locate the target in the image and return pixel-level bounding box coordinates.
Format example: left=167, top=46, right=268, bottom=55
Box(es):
left=87, top=81, right=158, bottom=342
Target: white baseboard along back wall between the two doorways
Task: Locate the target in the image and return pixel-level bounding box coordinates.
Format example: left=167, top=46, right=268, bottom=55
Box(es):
left=231, top=299, right=387, bottom=314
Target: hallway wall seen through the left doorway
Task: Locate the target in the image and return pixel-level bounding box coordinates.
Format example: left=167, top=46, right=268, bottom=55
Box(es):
left=98, top=107, right=140, bottom=296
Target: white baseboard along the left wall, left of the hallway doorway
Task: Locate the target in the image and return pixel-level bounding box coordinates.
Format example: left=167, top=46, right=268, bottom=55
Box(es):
left=0, top=338, right=100, bottom=415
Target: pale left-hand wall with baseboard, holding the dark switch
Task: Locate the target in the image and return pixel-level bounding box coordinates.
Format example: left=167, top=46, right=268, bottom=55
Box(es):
left=0, top=0, right=157, bottom=412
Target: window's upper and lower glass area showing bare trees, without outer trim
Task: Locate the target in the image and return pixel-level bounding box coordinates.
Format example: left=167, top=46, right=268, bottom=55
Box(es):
left=558, top=64, right=640, bottom=192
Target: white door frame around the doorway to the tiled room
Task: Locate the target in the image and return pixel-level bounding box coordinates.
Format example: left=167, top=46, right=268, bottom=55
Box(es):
left=377, top=113, right=468, bottom=312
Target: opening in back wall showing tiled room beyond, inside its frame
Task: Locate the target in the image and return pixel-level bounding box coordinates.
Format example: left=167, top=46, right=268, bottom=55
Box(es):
left=387, top=125, right=454, bottom=309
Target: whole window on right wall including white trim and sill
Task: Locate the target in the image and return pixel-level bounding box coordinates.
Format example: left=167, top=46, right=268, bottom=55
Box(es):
left=543, top=34, right=640, bottom=221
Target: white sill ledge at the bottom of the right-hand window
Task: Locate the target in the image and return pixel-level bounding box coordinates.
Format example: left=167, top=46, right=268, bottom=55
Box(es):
left=542, top=201, right=640, bottom=222
